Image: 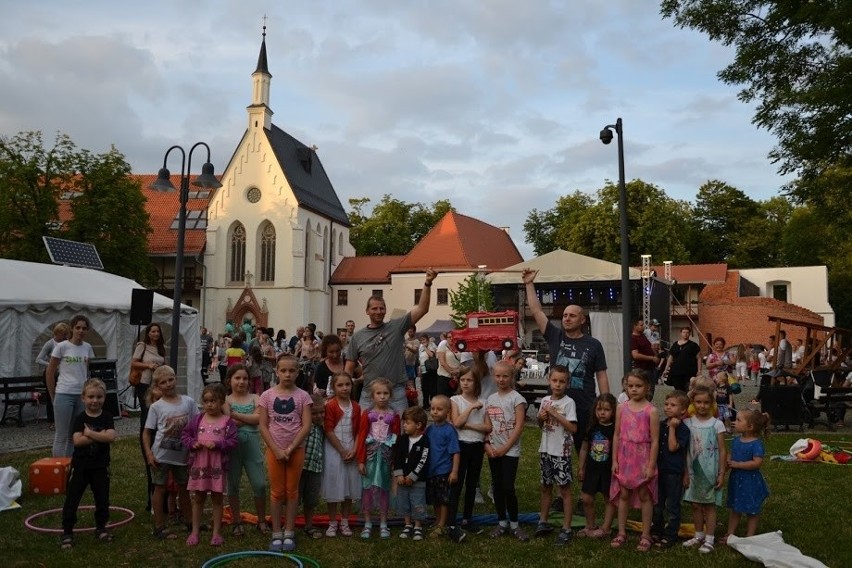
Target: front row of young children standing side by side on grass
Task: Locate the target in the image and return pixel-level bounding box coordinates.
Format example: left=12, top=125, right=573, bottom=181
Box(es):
left=61, top=355, right=768, bottom=553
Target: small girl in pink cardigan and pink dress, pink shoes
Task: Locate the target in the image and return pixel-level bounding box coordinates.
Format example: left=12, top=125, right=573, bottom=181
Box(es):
left=181, top=383, right=238, bottom=546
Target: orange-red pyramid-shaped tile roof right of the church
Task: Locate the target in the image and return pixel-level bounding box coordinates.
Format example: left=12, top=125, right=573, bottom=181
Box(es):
left=393, top=211, right=524, bottom=273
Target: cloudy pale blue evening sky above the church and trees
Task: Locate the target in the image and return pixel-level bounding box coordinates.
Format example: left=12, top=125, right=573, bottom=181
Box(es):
left=0, top=0, right=787, bottom=258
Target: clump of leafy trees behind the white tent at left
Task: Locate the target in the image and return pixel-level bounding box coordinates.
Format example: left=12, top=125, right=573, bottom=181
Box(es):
left=0, top=132, right=155, bottom=283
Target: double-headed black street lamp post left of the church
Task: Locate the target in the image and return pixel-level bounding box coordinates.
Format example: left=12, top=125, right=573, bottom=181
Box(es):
left=151, top=142, right=222, bottom=373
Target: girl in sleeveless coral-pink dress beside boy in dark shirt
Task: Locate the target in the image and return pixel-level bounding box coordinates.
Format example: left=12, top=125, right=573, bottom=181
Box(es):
left=609, top=369, right=660, bottom=552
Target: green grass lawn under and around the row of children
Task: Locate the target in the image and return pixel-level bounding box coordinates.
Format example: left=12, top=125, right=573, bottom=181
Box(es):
left=0, top=425, right=852, bottom=568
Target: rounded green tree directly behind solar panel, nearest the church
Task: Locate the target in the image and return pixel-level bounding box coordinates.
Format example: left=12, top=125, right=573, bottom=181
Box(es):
left=64, top=149, right=156, bottom=284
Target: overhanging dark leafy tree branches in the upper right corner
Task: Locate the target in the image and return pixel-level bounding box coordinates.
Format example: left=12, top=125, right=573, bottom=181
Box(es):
left=661, top=0, right=852, bottom=182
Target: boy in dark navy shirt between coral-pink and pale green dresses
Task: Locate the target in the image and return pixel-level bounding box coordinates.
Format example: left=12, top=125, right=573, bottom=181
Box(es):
left=651, top=390, right=689, bottom=548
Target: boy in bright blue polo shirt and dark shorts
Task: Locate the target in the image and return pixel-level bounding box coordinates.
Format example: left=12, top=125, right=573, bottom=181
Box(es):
left=426, top=395, right=465, bottom=542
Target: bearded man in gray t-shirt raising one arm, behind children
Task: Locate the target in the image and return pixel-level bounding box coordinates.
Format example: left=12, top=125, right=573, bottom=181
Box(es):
left=344, top=268, right=438, bottom=413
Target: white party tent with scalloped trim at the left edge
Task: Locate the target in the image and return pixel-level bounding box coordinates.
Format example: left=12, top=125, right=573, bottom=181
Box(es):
left=0, top=259, right=202, bottom=400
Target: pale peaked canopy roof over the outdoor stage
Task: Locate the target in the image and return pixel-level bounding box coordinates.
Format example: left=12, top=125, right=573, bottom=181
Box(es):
left=487, top=249, right=642, bottom=285
